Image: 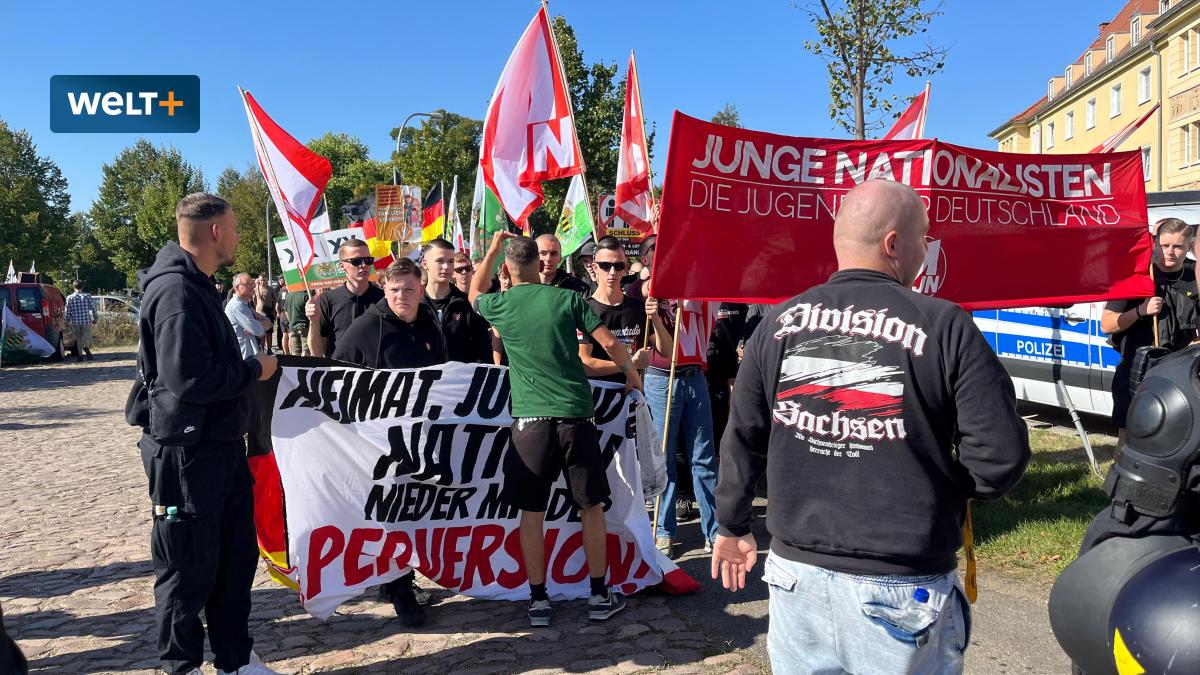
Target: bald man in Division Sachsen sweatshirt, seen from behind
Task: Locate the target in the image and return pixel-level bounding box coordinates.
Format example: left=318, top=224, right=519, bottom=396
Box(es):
left=712, top=180, right=1030, bottom=673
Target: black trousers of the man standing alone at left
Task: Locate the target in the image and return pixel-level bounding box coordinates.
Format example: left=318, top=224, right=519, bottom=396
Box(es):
left=138, top=436, right=258, bottom=673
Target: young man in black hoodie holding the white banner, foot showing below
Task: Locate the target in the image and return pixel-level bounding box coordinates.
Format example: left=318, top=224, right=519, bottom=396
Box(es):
left=334, top=258, right=446, bottom=627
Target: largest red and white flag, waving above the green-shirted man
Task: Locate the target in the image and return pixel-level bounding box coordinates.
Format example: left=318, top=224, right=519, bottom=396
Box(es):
left=479, top=6, right=583, bottom=227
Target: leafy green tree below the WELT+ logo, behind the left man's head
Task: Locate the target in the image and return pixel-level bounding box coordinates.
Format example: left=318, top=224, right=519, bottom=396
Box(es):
left=89, top=138, right=208, bottom=285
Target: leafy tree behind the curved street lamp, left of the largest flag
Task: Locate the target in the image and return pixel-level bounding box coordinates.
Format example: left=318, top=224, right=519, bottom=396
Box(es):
left=388, top=110, right=484, bottom=225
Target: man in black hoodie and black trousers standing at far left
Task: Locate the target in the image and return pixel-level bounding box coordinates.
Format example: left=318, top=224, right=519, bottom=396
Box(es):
left=125, top=193, right=276, bottom=675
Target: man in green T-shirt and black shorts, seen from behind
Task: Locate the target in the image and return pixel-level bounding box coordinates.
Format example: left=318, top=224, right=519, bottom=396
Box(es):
left=470, top=232, right=642, bottom=626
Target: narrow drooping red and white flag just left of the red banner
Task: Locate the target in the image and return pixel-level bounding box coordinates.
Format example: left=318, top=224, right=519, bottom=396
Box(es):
left=617, top=52, right=654, bottom=232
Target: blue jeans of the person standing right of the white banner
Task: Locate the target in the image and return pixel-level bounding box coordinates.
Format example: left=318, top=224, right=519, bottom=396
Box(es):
left=646, top=370, right=716, bottom=540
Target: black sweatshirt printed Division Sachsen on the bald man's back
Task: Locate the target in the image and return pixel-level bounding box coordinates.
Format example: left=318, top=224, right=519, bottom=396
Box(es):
left=716, top=269, right=1030, bottom=575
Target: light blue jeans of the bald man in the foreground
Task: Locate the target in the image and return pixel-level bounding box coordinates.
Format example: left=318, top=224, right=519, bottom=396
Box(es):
left=762, top=552, right=971, bottom=675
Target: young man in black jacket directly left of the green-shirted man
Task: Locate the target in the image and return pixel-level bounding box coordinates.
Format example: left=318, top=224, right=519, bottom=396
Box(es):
left=421, top=238, right=492, bottom=363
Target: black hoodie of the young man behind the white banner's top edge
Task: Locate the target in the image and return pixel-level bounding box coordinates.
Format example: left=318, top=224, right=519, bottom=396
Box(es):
left=334, top=298, right=446, bottom=368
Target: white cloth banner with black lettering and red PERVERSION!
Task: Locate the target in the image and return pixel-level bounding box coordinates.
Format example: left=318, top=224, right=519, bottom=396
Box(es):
left=270, top=363, right=690, bottom=619
